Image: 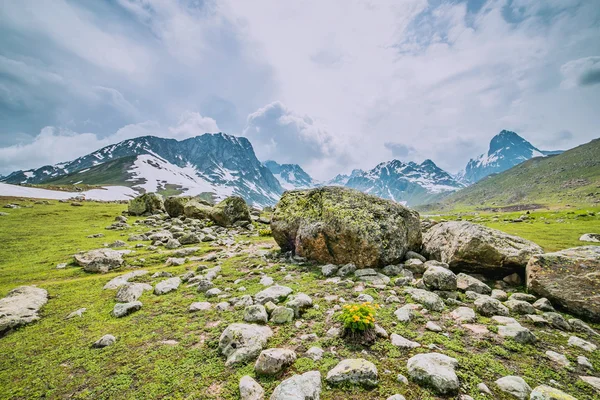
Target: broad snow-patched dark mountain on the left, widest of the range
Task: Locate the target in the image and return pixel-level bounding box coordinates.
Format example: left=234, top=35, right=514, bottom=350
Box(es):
left=2, top=133, right=283, bottom=206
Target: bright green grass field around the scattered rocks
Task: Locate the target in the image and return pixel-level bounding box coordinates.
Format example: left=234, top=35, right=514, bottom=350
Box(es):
left=0, top=198, right=600, bottom=400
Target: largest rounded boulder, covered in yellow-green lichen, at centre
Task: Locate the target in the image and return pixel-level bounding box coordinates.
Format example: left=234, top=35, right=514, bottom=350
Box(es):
left=271, top=187, right=421, bottom=268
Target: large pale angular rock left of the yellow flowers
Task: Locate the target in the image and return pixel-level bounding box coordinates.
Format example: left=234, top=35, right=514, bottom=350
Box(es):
left=219, top=323, right=273, bottom=367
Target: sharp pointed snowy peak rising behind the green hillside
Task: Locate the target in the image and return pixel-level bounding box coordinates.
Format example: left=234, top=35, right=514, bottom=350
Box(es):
left=456, top=130, right=561, bottom=184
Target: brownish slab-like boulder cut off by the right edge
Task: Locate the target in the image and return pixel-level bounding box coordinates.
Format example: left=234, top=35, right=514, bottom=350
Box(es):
left=526, top=246, right=600, bottom=321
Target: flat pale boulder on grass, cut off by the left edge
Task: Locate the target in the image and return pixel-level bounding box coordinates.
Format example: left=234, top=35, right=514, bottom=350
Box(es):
left=0, top=286, right=48, bottom=335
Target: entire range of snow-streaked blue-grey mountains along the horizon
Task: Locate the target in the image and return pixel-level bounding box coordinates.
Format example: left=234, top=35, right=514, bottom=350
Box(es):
left=0, top=131, right=560, bottom=206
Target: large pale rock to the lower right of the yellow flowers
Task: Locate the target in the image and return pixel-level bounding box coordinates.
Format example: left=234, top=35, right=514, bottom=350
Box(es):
left=407, top=353, right=459, bottom=395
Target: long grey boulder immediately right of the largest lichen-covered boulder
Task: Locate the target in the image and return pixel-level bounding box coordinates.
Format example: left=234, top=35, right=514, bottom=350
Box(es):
left=422, top=221, right=544, bottom=277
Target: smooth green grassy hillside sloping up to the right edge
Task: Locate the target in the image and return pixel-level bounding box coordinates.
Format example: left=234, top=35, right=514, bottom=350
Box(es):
left=429, top=139, right=600, bottom=209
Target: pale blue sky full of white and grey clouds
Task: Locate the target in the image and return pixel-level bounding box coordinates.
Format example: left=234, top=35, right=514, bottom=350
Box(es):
left=0, top=0, right=600, bottom=179
